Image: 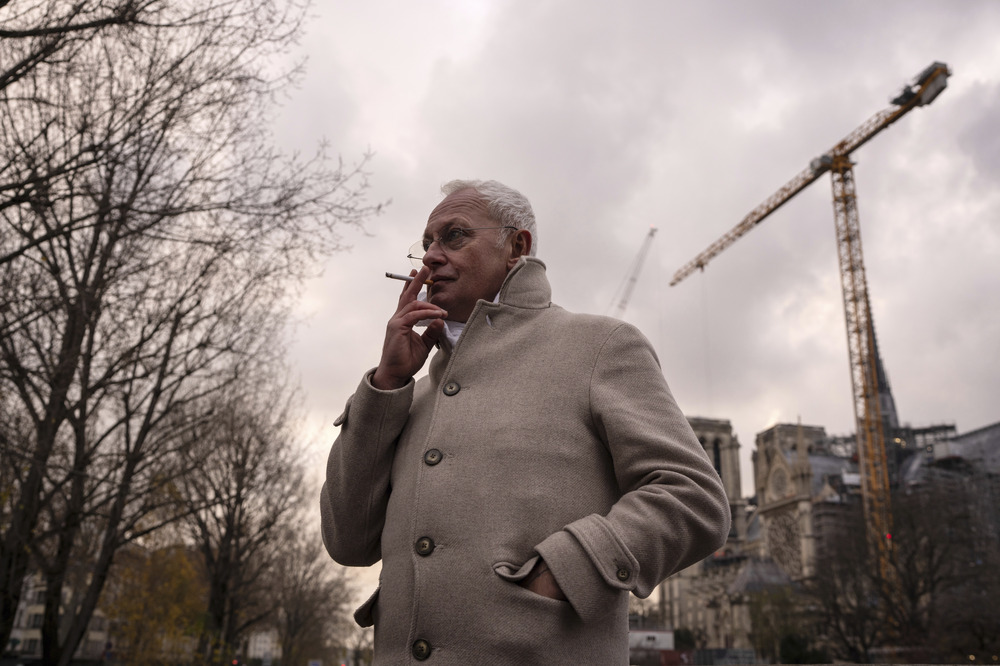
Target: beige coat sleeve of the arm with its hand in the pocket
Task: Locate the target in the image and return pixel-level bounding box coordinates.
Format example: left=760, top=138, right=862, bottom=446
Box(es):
left=536, top=324, right=731, bottom=622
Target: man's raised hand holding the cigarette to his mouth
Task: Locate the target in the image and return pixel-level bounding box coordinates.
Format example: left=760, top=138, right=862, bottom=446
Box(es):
left=371, top=266, right=448, bottom=391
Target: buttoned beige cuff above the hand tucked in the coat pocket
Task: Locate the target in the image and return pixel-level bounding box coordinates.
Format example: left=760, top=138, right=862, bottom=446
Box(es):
left=535, top=514, right=639, bottom=622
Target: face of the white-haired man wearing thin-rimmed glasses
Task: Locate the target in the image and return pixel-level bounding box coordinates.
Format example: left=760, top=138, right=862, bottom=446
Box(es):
left=423, top=189, right=512, bottom=322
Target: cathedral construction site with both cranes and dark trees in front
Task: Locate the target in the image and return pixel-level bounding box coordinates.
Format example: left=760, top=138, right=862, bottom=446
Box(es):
left=616, top=62, right=1000, bottom=664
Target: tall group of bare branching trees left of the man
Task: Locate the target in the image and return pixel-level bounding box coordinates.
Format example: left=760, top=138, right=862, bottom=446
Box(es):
left=0, top=0, right=379, bottom=664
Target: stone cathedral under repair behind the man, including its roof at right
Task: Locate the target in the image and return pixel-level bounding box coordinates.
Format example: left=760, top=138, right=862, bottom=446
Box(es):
left=651, top=417, right=1000, bottom=652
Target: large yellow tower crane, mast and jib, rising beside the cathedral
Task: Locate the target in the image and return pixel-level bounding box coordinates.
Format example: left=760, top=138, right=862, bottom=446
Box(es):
left=670, top=62, right=951, bottom=580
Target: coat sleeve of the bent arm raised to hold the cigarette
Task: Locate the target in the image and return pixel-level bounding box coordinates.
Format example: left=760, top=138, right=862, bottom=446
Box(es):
left=320, top=372, right=414, bottom=566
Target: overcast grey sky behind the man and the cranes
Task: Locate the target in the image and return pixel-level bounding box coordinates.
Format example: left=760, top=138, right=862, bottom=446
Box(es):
left=275, top=0, right=1000, bottom=572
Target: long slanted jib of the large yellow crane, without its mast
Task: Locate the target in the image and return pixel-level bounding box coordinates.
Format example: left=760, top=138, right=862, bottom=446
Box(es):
left=670, top=62, right=951, bottom=287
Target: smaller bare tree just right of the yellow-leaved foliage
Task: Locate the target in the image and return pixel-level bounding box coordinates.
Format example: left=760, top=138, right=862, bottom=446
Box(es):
left=177, top=373, right=305, bottom=663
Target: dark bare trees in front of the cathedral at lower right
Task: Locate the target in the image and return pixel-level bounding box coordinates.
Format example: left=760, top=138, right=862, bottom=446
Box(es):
left=751, top=469, right=1000, bottom=663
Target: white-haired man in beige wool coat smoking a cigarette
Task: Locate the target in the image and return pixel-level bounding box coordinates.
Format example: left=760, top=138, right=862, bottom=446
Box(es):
left=321, top=181, right=730, bottom=664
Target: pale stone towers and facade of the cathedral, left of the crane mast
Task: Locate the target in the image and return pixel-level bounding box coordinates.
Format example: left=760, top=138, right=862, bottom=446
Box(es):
left=658, top=418, right=859, bottom=649
